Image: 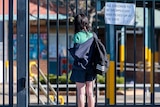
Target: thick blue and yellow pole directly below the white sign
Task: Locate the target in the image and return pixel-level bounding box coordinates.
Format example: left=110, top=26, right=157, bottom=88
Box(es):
left=106, top=25, right=115, bottom=105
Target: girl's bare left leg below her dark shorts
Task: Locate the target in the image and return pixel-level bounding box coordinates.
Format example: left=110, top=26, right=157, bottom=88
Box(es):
left=76, top=82, right=85, bottom=107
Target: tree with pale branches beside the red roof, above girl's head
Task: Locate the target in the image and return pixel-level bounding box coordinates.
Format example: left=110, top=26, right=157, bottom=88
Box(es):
left=30, top=0, right=104, bottom=26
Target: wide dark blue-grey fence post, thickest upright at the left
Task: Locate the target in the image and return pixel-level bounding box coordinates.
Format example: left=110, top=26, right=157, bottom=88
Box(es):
left=17, top=0, right=29, bottom=107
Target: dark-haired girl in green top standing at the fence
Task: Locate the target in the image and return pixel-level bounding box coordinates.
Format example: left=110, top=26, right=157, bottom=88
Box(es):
left=69, top=14, right=96, bottom=107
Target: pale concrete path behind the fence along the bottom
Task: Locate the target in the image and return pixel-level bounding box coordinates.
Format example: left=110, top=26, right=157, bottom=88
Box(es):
left=0, top=90, right=160, bottom=105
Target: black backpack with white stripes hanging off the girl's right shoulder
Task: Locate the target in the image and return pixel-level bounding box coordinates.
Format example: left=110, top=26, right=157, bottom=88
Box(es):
left=93, top=32, right=109, bottom=75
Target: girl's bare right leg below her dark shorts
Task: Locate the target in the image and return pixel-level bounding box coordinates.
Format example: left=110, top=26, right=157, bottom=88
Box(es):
left=86, top=81, right=95, bottom=107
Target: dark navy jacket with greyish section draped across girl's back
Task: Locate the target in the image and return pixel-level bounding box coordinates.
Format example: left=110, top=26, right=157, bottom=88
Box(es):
left=69, top=37, right=94, bottom=70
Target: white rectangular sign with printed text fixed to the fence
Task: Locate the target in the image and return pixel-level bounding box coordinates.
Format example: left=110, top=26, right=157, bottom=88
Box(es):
left=105, top=2, right=135, bottom=25
